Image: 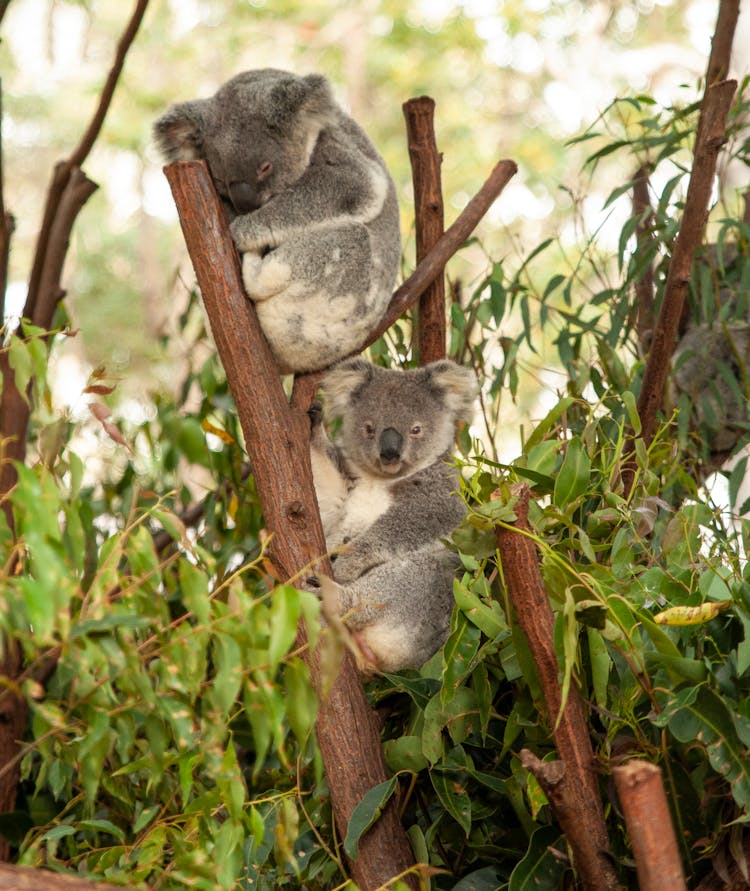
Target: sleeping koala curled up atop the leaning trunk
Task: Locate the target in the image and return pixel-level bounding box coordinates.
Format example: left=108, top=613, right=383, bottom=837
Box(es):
left=154, top=68, right=401, bottom=373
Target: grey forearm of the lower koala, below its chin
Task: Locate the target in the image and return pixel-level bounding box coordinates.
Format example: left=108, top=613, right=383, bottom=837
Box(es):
left=334, top=461, right=465, bottom=583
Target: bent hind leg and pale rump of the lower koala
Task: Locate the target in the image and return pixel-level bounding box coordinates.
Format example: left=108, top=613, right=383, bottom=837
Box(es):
left=333, top=543, right=457, bottom=672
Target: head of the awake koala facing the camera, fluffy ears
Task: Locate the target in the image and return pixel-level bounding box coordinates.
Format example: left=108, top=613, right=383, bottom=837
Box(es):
left=322, top=359, right=476, bottom=478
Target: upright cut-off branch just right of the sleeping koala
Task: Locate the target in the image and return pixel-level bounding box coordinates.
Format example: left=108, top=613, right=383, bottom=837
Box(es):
left=403, top=96, right=446, bottom=365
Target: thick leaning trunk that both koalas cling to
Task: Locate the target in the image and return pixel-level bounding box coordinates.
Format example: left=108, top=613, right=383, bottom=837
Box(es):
left=165, top=161, right=416, bottom=891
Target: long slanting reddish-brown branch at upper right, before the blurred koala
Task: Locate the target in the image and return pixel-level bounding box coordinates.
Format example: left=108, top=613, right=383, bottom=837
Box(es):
left=623, top=81, right=737, bottom=492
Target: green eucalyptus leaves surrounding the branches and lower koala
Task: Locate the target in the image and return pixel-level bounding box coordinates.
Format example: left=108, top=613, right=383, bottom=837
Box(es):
left=0, top=75, right=750, bottom=891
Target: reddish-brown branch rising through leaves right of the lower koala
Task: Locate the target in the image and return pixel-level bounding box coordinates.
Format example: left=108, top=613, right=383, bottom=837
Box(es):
left=497, top=483, right=619, bottom=891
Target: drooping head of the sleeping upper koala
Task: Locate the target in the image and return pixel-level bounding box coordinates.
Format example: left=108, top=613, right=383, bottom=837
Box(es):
left=154, top=68, right=339, bottom=214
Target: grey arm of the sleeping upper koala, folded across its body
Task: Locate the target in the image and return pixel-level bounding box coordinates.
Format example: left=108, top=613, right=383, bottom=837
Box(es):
left=230, top=132, right=390, bottom=252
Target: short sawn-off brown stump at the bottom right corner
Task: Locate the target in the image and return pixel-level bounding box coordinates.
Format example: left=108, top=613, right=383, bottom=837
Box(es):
left=612, top=760, right=687, bottom=891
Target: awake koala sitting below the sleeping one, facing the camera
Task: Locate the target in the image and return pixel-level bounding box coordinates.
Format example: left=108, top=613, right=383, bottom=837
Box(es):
left=311, top=359, right=476, bottom=672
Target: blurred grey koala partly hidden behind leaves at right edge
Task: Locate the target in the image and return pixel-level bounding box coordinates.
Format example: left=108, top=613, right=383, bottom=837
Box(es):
left=673, top=323, right=750, bottom=454
